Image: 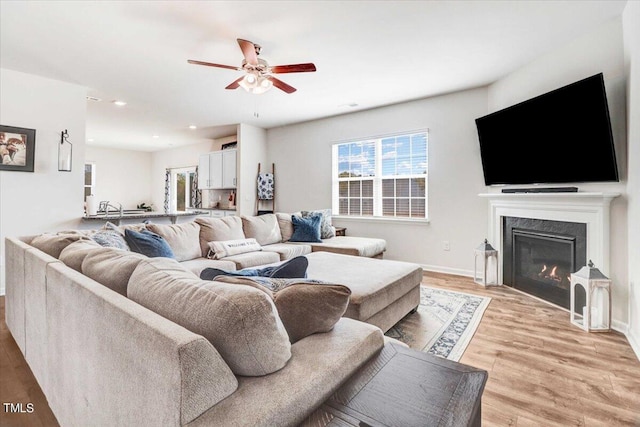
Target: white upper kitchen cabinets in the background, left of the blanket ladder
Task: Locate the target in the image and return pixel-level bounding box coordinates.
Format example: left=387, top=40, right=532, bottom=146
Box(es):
left=198, top=150, right=237, bottom=190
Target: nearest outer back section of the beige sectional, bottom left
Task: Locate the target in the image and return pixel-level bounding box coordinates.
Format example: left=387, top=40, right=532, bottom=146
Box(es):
left=46, top=263, right=237, bottom=426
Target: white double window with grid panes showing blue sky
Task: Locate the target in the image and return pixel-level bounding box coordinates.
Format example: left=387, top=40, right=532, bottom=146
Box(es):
left=333, top=130, right=428, bottom=219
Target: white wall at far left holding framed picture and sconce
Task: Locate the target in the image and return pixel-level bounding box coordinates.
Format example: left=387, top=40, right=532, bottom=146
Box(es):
left=0, top=69, right=87, bottom=294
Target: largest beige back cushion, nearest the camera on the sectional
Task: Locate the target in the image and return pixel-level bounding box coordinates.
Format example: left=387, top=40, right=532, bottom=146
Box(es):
left=127, top=258, right=291, bottom=376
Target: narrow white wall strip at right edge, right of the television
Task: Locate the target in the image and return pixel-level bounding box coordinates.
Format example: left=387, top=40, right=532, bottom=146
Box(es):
left=623, top=1, right=640, bottom=358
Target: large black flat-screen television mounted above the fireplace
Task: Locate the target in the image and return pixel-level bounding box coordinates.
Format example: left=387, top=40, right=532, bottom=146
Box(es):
left=476, top=73, right=618, bottom=185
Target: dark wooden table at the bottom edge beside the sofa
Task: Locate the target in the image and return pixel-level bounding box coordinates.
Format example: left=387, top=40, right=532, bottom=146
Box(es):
left=302, top=344, right=487, bottom=427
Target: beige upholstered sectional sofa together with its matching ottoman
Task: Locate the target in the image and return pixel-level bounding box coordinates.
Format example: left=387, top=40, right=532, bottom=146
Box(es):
left=5, top=215, right=422, bottom=426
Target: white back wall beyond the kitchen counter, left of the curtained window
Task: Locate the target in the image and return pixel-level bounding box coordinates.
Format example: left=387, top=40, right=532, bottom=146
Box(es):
left=85, top=145, right=153, bottom=209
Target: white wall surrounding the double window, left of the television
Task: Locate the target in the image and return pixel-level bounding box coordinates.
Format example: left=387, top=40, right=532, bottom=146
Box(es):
left=267, top=89, right=487, bottom=275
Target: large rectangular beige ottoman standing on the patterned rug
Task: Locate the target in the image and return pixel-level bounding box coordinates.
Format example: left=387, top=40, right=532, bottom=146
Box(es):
left=306, top=252, right=422, bottom=332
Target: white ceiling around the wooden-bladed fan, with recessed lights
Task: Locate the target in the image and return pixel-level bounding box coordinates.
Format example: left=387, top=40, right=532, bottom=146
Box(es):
left=0, top=0, right=626, bottom=151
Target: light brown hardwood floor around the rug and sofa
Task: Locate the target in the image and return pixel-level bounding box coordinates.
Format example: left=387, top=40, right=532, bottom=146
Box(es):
left=0, top=273, right=640, bottom=427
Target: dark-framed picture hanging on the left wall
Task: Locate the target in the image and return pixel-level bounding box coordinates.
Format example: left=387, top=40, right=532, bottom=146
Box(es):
left=0, top=125, right=36, bottom=172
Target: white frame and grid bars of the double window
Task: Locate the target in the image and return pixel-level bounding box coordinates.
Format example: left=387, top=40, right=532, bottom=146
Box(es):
left=331, top=128, right=429, bottom=223
